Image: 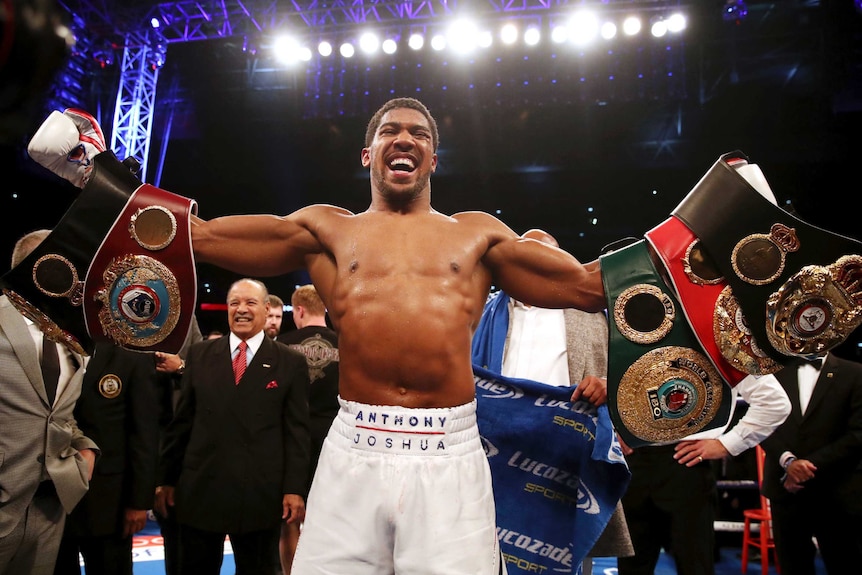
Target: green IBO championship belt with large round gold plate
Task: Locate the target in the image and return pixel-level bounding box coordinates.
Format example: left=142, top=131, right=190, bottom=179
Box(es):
left=600, top=240, right=732, bottom=447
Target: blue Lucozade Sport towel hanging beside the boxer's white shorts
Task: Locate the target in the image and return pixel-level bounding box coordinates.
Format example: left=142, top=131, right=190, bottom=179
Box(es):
left=473, top=365, right=631, bottom=575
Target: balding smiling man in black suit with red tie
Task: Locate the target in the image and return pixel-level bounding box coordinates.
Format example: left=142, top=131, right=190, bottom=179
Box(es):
left=156, top=278, right=310, bottom=575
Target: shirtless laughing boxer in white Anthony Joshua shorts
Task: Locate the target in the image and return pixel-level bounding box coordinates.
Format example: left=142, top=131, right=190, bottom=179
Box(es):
left=27, top=98, right=605, bottom=575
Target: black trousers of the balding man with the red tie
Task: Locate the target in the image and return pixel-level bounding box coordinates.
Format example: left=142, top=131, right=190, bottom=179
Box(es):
left=179, top=523, right=281, bottom=575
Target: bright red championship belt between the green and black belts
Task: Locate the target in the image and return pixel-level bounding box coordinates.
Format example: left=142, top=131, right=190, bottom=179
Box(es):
left=645, top=216, right=782, bottom=387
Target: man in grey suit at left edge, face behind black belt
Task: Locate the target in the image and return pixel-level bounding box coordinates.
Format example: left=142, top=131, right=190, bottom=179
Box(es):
left=0, top=230, right=98, bottom=575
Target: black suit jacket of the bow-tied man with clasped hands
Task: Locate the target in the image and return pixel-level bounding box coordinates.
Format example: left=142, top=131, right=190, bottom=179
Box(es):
left=762, top=353, right=862, bottom=512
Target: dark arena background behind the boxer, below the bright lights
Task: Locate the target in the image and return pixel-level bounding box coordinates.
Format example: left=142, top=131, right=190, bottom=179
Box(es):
left=0, top=0, right=862, bottom=359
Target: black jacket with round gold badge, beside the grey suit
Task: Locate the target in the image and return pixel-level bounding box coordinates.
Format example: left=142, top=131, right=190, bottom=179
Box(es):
left=66, top=343, right=159, bottom=536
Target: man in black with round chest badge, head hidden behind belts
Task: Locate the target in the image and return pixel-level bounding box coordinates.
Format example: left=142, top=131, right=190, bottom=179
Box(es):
left=54, top=343, right=159, bottom=575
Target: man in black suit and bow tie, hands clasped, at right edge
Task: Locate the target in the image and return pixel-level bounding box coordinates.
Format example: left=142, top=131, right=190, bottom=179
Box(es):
left=761, top=354, right=862, bottom=575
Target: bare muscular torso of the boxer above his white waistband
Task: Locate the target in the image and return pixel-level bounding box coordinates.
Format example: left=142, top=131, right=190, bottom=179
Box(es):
left=308, top=212, right=491, bottom=407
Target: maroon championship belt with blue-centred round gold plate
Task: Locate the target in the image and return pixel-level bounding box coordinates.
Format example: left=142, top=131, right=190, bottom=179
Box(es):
left=84, top=154, right=197, bottom=353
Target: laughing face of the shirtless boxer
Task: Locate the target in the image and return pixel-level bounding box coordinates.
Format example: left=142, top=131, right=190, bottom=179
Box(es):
left=362, top=108, right=437, bottom=205
